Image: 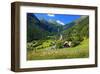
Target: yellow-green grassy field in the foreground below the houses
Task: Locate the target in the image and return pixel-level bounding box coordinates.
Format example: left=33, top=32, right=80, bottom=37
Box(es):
left=27, top=39, right=89, bottom=60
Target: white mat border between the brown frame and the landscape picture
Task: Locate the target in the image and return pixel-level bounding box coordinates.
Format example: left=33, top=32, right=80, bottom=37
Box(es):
left=20, top=6, right=95, bottom=68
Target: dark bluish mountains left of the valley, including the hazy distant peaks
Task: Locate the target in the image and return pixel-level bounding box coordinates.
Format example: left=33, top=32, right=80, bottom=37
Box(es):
left=27, top=13, right=63, bottom=42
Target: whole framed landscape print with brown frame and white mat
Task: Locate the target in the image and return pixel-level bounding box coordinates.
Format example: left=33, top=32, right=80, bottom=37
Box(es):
left=11, top=2, right=97, bottom=72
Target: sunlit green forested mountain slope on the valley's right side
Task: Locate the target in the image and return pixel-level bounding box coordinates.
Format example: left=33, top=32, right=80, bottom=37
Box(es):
left=62, top=16, right=89, bottom=41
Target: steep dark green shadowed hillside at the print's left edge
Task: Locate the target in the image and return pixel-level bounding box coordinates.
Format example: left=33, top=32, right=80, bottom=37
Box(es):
left=27, top=14, right=49, bottom=42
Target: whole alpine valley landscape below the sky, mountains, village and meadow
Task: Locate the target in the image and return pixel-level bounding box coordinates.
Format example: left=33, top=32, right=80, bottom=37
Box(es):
left=27, top=13, right=89, bottom=60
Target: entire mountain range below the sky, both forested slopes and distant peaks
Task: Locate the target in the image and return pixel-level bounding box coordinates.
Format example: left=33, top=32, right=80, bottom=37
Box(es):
left=27, top=13, right=89, bottom=42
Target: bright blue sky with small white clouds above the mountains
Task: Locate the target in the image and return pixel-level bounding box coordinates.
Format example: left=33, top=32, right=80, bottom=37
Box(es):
left=34, top=13, right=81, bottom=25
